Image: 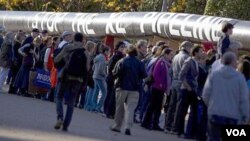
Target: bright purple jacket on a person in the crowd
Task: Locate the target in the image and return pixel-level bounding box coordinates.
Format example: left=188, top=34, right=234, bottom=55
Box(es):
left=152, top=57, right=171, bottom=92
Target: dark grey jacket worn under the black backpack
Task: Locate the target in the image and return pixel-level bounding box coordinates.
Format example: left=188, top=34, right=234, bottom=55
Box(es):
left=54, top=42, right=89, bottom=83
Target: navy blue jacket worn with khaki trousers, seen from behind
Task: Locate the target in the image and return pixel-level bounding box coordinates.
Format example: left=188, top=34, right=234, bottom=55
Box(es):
left=113, top=56, right=147, bottom=91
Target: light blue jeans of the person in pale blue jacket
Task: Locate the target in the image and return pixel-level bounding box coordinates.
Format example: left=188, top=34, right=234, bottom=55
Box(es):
left=92, top=79, right=107, bottom=112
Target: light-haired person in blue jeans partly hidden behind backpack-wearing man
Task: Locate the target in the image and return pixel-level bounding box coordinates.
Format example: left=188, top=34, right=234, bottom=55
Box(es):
left=80, top=41, right=97, bottom=111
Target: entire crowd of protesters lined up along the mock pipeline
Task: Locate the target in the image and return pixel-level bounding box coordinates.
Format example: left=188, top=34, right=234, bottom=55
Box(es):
left=0, top=23, right=250, bottom=141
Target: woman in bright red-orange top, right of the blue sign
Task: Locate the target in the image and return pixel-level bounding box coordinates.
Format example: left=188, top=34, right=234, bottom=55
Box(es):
left=44, top=37, right=60, bottom=102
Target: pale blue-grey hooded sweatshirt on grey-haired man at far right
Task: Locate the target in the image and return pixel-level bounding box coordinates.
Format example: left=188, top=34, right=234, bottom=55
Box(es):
left=203, top=66, right=249, bottom=123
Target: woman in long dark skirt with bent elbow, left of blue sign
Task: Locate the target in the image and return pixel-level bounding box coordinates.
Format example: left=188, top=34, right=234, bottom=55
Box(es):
left=14, top=37, right=41, bottom=96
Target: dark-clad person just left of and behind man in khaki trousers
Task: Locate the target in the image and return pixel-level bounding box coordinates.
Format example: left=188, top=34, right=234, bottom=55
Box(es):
left=104, top=41, right=126, bottom=119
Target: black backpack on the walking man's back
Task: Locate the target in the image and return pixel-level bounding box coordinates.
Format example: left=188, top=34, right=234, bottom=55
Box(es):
left=64, top=48, right=87, bottom=81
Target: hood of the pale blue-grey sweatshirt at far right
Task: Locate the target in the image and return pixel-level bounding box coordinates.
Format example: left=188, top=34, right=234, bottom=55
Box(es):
left=218, top=66, right=238, bottom=79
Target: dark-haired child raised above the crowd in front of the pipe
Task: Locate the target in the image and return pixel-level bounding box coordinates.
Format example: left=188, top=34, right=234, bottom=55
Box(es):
left=217, top=22, right=234, bottom=57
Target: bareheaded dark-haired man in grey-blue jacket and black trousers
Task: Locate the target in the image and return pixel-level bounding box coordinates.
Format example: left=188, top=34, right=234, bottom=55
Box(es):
left=176, top=45, right=203, bottom=138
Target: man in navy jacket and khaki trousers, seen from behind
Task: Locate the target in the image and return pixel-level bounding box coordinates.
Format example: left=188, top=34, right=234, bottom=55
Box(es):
left=110, top=45, right=147, bottom=135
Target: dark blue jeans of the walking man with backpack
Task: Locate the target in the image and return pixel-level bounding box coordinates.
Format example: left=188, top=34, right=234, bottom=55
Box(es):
left=56, top=80, right=81, bottom=128
